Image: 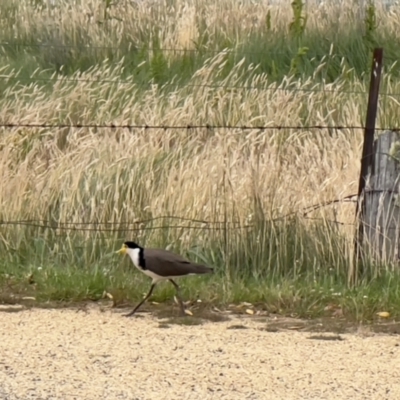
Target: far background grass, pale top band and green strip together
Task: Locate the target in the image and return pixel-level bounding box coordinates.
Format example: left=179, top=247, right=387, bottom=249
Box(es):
left=0, top=0, right=400, bottom=85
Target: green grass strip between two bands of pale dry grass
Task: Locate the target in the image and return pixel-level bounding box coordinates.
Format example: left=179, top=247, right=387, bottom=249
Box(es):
left=0, top=30, right=400, bottom=91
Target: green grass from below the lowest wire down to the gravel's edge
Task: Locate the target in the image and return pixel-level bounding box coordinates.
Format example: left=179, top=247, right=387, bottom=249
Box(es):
left=0, top=221, right=400, bottom=321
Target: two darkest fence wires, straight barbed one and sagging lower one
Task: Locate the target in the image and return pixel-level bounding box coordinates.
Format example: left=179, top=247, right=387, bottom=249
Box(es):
left=0, top=123, right=376, bottom=236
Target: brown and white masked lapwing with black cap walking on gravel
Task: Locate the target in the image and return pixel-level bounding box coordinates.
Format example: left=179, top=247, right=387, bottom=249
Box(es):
left=117, top=242, right=213, bottom=317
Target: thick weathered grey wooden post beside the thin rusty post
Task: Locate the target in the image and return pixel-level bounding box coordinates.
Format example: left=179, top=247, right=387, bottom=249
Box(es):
left=361, top=131, right=400, bottom=263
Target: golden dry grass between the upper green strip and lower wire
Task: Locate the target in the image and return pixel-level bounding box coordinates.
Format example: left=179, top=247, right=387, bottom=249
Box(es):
left=0, top=53, right=398, bottom=252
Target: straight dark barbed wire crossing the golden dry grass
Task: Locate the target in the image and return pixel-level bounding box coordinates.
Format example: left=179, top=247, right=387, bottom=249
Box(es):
left=0, top=122, right=394, bottom=132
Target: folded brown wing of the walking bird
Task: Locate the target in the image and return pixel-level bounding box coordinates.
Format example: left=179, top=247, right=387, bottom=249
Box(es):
left=144, top=249, right=212, bottom=276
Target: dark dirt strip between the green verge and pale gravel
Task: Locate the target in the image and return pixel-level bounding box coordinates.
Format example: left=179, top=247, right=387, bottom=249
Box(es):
left=0, top=296, right=400, bottom=340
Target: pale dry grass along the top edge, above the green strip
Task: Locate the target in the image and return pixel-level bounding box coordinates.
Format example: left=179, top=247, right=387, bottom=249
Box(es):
left=1, top=0, right=399, bottom=48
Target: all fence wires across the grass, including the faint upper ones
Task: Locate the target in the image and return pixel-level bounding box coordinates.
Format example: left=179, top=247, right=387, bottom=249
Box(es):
left=0, top=42, right=394, bottom=238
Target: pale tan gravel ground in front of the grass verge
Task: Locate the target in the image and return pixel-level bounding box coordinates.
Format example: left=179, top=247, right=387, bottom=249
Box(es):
left=0, top=306, right=400, bottom=400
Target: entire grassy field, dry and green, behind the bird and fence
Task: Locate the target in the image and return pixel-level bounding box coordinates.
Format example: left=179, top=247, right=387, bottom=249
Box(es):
left=0, top=0, right=400, bottom=320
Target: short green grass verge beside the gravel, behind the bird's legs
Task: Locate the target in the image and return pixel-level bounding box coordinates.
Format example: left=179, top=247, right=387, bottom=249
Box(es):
left=0, top=260, right=400, bottom=322
